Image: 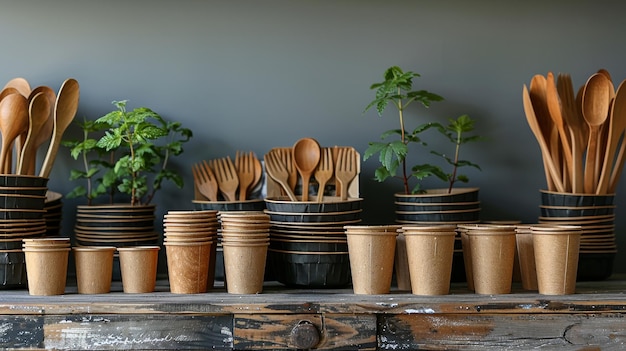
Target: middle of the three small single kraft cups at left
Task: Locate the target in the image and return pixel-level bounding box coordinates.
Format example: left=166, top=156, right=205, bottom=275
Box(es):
left=73, top=246, right=116, bottom=294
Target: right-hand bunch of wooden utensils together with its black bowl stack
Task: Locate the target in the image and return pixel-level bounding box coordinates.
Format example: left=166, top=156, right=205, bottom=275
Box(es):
left=523, top=69, right=626, bottom=280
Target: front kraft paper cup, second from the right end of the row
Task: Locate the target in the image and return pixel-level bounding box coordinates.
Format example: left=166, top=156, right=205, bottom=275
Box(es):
left=467, top=226, right=515, bottom=295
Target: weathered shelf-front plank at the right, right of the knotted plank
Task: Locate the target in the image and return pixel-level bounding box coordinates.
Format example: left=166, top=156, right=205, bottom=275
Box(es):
left=378, top=314, right=626, bottom=350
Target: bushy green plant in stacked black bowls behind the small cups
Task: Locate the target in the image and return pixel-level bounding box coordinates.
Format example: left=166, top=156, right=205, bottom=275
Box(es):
left=64, top=100, right=192, bottom=250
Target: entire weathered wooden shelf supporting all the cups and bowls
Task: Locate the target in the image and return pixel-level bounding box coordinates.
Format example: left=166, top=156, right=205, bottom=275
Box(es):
left=0, top=277, right=626, bottom=350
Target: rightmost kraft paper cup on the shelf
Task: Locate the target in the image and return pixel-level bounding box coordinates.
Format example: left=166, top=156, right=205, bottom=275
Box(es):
left=530, top=226, right=582, bottom=295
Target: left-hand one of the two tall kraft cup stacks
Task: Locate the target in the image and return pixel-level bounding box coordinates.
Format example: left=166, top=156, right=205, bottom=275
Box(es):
left=163, top=210, right=219, bottom=294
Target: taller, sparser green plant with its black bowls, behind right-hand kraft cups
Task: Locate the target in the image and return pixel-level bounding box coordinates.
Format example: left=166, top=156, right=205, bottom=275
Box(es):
left=363, top=66, right=481, bottom=290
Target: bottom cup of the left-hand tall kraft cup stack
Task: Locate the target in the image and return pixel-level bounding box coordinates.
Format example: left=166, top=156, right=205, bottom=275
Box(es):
left=164, top=241, right=213, bottom=294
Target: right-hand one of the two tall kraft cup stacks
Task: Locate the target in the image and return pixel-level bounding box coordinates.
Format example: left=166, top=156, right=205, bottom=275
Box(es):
left=219, top=211, right=270, bottom=294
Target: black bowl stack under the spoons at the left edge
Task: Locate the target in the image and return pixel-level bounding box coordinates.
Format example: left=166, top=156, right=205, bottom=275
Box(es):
left=0, top=174, right=48, bottom=288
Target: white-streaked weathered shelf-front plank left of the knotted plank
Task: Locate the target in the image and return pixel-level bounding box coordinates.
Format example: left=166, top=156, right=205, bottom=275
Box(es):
left=33, top=314, right=232, bottom=350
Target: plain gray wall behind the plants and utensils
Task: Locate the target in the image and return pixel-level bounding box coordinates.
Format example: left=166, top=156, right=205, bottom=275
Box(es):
left=0, top=0, right=626, bottom=271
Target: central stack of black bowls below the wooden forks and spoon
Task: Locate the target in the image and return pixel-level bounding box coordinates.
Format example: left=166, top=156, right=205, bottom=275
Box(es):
left=265, top=196, right=362, bottom=288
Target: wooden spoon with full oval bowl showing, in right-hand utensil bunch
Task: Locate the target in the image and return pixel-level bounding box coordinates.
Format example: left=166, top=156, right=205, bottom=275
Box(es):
left=582, top=73, right=611, bottom=194
